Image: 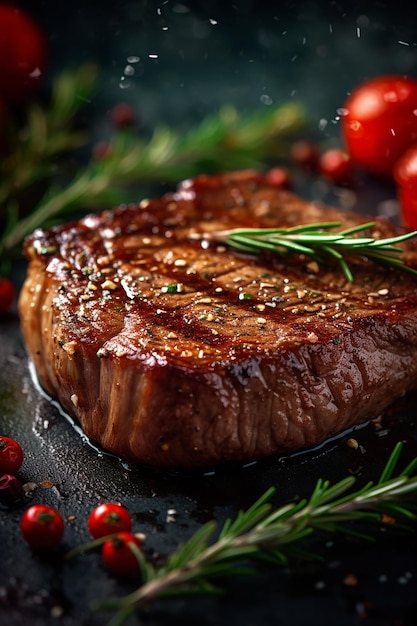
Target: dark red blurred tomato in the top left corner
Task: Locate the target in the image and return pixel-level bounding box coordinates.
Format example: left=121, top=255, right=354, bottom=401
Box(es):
left=0, top=4, right=47, bottom=102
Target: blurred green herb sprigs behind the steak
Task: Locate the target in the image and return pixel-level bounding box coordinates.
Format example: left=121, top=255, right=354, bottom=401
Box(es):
left=0, top=65, right=307, bottom=274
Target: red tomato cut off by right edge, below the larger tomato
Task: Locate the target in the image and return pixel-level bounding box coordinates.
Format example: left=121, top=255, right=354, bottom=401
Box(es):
left=394, top=144, right=417, bottom=230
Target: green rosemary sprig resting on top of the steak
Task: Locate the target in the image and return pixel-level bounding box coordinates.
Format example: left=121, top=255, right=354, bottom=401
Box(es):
left=204, top=222, right=417, bottom=282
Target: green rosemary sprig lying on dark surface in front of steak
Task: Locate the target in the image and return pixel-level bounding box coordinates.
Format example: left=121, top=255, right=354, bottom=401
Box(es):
left=73, top=443, right=417, bottom=626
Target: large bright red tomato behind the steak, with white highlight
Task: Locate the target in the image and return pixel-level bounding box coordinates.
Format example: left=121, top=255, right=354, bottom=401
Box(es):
left=341, top=75, right=417, bottom=178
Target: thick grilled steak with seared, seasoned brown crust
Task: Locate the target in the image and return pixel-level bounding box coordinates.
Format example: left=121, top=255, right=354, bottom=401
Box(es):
left=19, top=171, right=417, bottom=467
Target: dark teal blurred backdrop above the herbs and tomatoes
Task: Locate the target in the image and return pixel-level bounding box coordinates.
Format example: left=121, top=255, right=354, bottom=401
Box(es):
left=16, top=0, right=417, bottom=138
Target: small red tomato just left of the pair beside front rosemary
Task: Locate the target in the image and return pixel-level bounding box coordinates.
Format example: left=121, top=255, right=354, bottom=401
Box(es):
left=20, top=504, right=64, bottom=549
